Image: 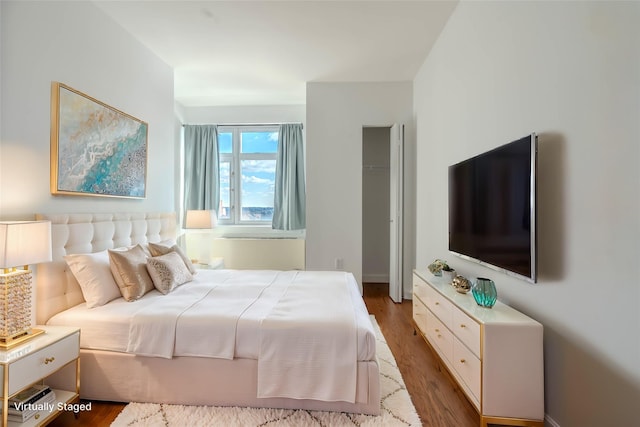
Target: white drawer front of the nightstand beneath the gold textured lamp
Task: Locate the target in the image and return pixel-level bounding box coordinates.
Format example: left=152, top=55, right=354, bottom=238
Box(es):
left=9, top=332, right=80, bottom=395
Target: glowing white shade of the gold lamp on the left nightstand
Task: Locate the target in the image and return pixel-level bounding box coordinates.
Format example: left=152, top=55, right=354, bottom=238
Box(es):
left=0, top=221, right=51, bottom=268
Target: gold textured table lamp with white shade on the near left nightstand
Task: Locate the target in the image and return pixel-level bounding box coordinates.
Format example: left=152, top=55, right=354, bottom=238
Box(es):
left=0, top=221, right=51, bottom=348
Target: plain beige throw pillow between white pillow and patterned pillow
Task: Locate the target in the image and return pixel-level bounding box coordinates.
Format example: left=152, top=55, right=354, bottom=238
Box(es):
left=109, top=245, right=153, bottom=301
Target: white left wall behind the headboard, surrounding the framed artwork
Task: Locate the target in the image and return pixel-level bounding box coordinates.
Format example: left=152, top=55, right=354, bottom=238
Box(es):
left=0, top=0, right=178, bottom=220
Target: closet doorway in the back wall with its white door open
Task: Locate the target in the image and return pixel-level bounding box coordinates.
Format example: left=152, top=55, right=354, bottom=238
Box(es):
left=362, top=125, right=403, bottom=302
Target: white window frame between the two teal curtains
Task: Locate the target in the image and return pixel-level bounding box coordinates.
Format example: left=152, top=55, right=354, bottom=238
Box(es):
left=218, top=125, right=280, bottom=226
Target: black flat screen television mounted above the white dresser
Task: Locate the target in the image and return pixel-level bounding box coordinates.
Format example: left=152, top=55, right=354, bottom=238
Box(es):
left=449, top=133, right=538, bottom=283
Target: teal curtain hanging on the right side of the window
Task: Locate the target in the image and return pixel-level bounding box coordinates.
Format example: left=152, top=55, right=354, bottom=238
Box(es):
left=272, top=123, right=307, bottom=230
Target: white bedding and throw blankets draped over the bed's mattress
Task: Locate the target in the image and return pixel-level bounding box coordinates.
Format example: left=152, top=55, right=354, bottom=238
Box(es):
left=48, top=270, right=375, bottom=402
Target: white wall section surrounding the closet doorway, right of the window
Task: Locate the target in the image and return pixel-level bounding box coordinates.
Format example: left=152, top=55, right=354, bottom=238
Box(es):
left=306, top=82, right=415, bottom=294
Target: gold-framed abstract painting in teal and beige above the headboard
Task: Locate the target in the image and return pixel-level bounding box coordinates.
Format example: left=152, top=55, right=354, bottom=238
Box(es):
left=51, top=82, right=149, bottom=199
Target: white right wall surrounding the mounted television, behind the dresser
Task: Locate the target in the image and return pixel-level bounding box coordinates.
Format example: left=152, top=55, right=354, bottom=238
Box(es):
left=414, top=2, right=640, bottom=427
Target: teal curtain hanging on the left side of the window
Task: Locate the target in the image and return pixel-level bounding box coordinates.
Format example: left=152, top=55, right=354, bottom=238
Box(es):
left=184, top=125, right=220, bottom=215
